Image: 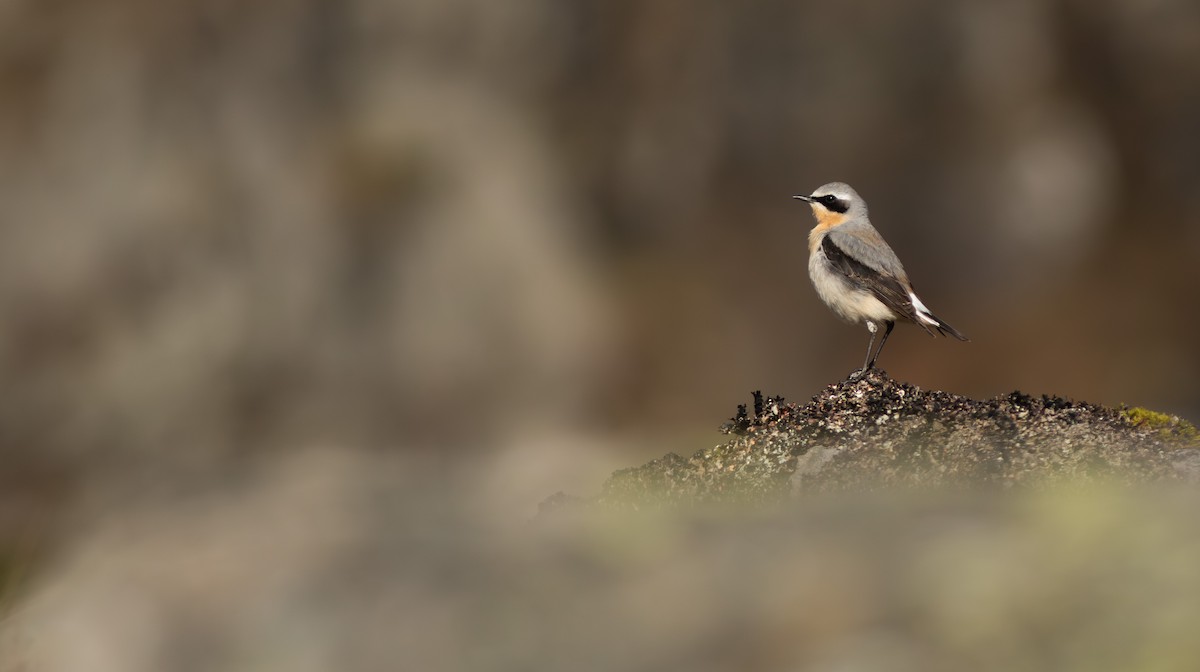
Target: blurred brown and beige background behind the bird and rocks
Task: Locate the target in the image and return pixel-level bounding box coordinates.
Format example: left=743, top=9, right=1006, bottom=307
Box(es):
left=0, top=0, right=1200, bottom=667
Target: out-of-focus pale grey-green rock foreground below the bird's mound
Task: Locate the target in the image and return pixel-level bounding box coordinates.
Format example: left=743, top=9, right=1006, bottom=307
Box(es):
left=0, top=451, right=1200, bottom=672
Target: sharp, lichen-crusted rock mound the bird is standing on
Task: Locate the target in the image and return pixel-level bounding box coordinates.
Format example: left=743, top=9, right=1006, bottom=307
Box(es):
left=599, top=370, right=1200, bottom=505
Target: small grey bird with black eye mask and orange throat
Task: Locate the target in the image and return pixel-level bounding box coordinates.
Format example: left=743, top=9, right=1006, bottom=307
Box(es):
left=793, top=182, right=967, bottom=376
